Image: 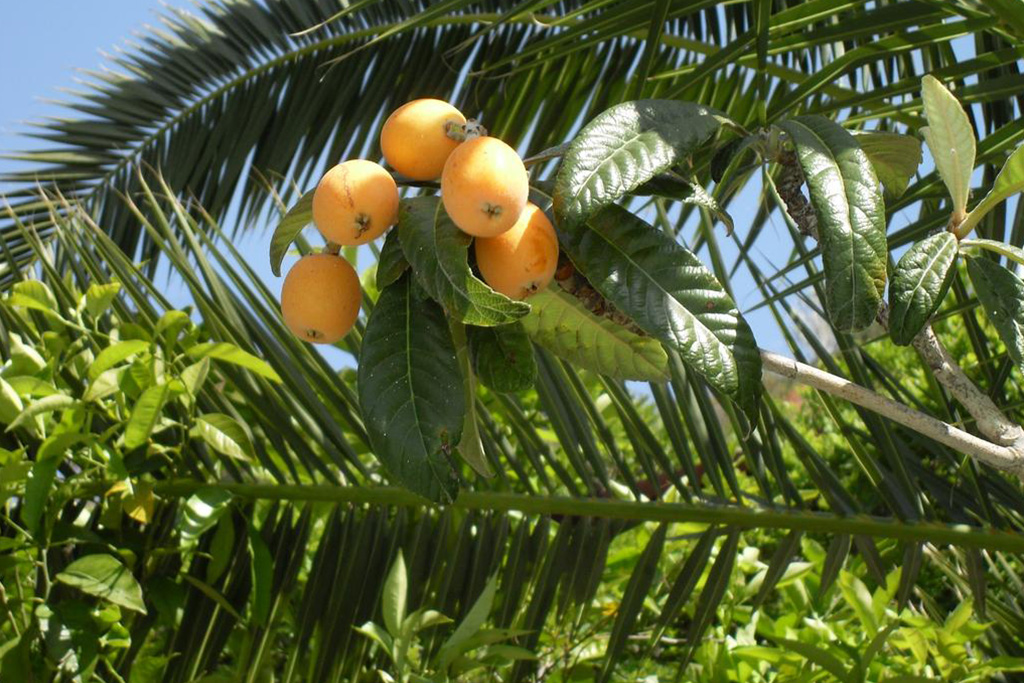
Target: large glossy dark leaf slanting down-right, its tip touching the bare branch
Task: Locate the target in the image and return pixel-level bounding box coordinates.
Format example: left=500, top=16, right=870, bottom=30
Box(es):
left=558, top=206, right=761, bottom=413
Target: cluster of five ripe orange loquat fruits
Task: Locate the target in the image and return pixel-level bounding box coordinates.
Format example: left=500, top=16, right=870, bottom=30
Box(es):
left=281, top=99, right=558, bottom=344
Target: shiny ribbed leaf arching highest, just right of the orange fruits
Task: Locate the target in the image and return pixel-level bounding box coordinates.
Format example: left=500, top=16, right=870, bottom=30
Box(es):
left=554, top=99, right=720, bottom=228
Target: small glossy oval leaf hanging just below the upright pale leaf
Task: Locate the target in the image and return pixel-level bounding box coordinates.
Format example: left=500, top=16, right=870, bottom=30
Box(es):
left=889, top=230, right=956, bottom=346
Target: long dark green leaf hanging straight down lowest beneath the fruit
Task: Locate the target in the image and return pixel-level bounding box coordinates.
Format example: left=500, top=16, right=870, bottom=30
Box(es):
left=357, top=273, right=466, bottom=501
